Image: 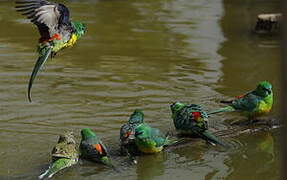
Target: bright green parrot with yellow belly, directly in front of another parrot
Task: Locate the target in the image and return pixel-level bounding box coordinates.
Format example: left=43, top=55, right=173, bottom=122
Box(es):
left=135, top=123, right=175, bottom=154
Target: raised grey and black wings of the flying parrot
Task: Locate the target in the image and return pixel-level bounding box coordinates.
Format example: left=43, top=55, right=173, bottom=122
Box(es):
left=16, top=0, right=70, bottom=40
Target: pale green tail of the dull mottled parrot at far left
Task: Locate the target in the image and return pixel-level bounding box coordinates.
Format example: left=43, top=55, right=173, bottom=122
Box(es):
left=39, top=158, right=77, bottom=179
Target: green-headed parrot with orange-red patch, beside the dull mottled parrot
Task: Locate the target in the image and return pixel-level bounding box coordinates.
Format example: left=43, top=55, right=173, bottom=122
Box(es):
left=80, top=128, right=114, bottom=168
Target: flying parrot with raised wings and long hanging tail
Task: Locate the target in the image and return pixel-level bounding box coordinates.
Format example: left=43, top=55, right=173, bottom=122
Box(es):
left=16, top=0, right=86, bottom=102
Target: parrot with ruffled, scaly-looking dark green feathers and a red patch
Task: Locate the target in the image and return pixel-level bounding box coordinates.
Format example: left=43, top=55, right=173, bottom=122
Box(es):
left=170, top=102, right=227, bottom=147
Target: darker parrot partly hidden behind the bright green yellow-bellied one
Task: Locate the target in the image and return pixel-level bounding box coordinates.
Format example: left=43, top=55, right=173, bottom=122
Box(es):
left=120, top=109, right=144, bottom=164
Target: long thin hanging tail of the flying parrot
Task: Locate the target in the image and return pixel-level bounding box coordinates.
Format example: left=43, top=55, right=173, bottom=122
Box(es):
left=28, top=46, right=52, bottom=102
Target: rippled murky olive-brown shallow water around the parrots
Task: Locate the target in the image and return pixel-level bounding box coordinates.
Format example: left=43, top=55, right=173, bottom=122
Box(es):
left=0, top=0, right=281, bottom=180
